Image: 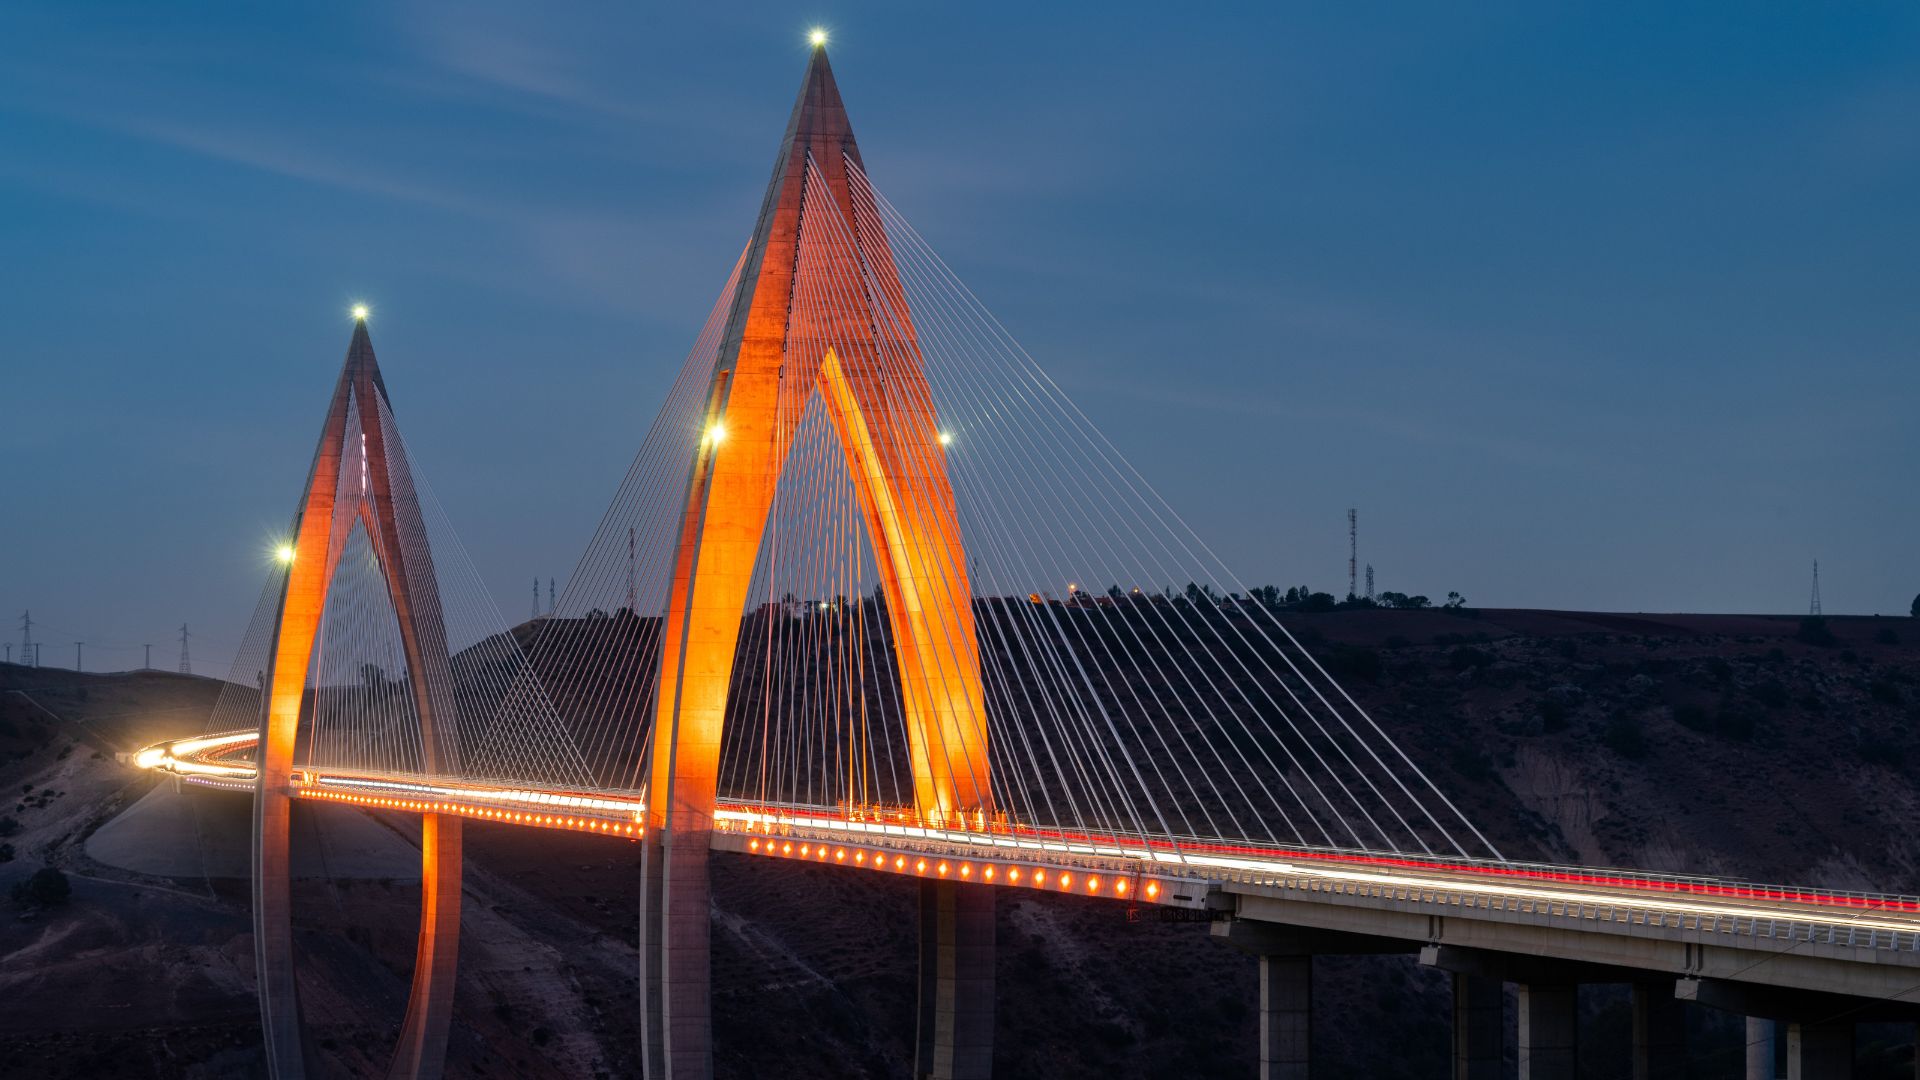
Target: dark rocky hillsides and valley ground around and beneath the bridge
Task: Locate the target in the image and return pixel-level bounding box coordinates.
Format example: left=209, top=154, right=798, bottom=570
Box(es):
left=0, top=609, right=1920, bottom=1078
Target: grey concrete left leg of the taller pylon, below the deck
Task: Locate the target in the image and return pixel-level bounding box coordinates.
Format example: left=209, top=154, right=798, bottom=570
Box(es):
left=639, top=834, right=712, bottom=1080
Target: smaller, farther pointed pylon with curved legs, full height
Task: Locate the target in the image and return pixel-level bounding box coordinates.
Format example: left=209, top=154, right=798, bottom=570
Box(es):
left=253, top=317, right=461, bottom=1080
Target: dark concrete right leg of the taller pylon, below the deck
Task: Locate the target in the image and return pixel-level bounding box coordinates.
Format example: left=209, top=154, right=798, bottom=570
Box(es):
left=914, top=882, right=995, bottom=1080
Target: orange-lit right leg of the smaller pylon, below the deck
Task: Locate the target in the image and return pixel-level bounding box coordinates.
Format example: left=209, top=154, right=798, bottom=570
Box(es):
left=386, top=813, right=461, bottom=1080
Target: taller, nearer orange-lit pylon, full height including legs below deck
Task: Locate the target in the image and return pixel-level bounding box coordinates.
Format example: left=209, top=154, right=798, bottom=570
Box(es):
left=641, top=42, right=993, bottom=1080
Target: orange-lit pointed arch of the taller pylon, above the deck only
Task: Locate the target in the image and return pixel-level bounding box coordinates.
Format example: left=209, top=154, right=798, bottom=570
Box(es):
left=647, top=48, right=991, bottom=828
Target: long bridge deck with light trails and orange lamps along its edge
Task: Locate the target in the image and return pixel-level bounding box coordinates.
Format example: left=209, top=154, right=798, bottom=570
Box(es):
left=134, top=732, right=1920, bottom=997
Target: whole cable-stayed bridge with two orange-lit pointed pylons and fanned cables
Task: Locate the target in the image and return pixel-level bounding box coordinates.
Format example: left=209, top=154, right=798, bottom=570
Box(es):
left=138, top=42, right=1920, bottom=1078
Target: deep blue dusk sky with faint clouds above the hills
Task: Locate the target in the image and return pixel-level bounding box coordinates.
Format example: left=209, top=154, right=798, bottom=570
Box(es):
left=0, top=2, right=1920, bottom=673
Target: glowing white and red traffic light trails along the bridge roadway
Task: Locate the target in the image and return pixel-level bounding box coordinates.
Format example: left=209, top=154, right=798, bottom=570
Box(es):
left=132, top=730, right=1920, bottom=934
